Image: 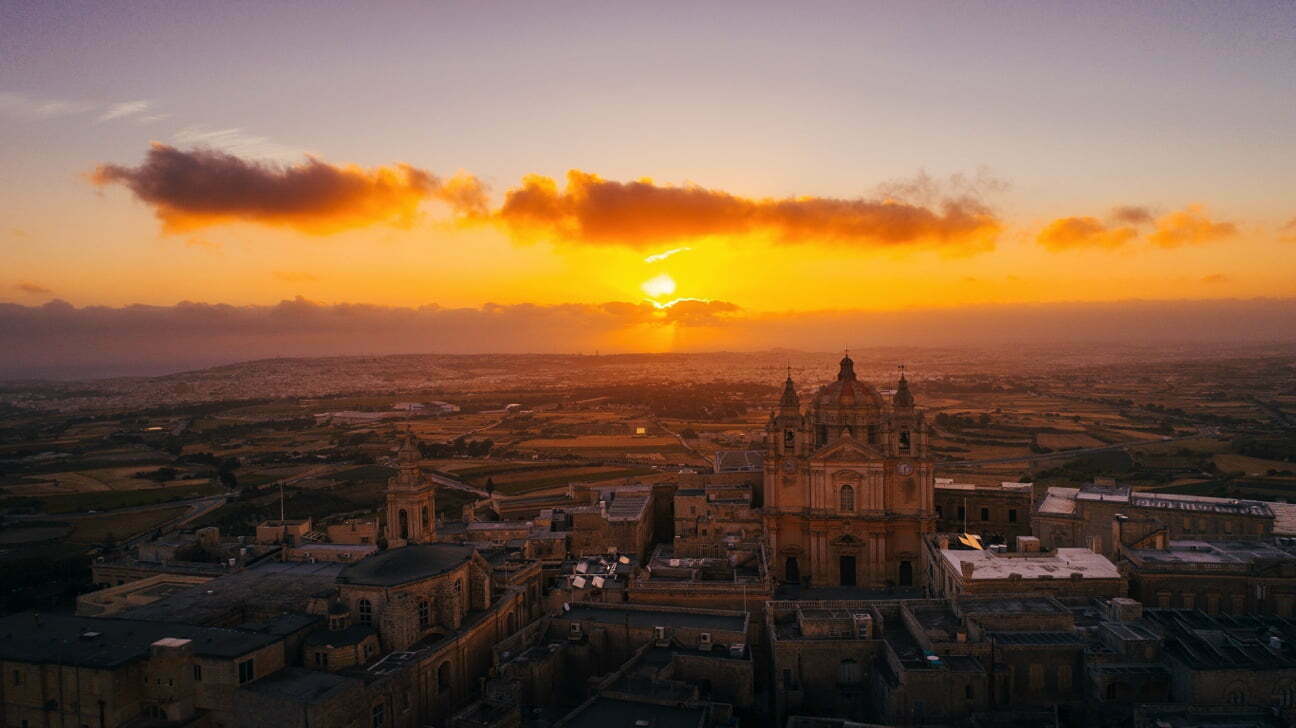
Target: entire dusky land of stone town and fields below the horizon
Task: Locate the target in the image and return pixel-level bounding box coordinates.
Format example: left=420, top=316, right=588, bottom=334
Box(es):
left=0, top=345, right=1296, bottom=728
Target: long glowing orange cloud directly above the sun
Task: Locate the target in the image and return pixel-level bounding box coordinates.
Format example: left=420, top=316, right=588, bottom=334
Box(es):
left=494, top=170, right=1002, bottom=253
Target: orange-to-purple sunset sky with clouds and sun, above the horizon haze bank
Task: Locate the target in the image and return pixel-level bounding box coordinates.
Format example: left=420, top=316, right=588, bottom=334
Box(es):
left=0, top=0, right=1296, bottom=370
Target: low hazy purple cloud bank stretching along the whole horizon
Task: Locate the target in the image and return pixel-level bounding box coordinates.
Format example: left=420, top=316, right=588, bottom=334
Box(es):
left=0, top=298, right=1296, bottom=378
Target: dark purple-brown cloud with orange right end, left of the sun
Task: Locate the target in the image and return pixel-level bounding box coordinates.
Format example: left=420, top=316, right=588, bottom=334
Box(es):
left=89, top=144, right=474, bottom=234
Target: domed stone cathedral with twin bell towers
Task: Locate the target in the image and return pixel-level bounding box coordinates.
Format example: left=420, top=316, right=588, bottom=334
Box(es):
left=763, top=355, right=936, bottom=587
